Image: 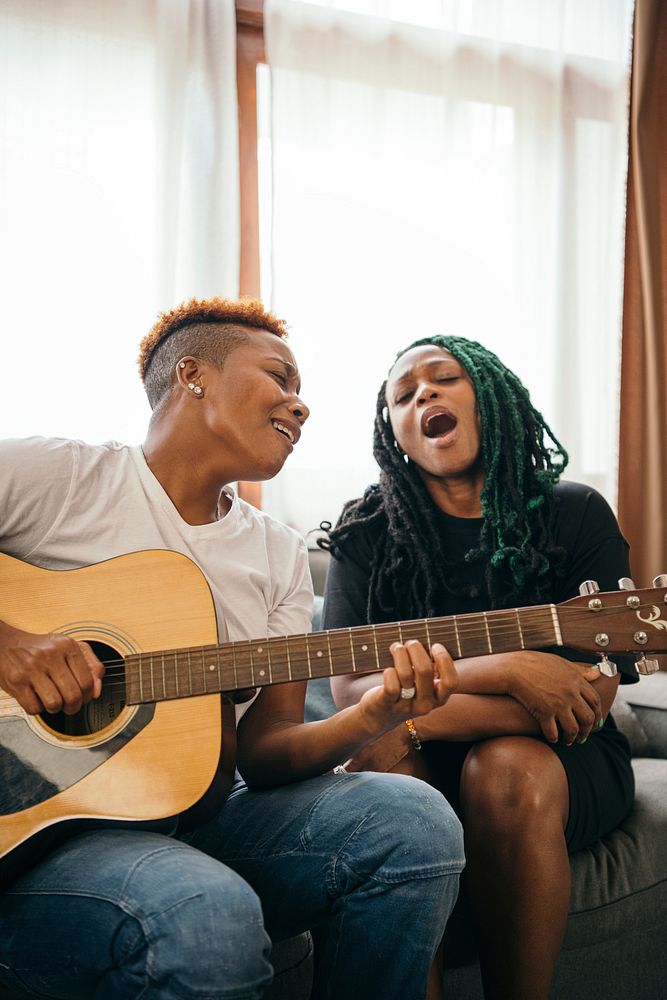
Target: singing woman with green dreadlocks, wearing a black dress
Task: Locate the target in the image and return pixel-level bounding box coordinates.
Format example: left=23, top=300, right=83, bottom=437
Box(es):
left=324, top=337, right=635, bottom=1000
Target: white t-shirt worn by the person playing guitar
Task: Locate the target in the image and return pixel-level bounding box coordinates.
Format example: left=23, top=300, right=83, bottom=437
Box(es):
left=0, top=437, right=313, bottom=708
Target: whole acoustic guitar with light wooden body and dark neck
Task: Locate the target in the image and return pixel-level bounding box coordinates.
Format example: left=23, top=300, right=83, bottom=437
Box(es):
left=0, top=550, right=667, bottom=887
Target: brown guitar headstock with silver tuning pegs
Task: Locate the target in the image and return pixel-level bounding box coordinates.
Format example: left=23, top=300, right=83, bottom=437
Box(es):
left=558, top=575, right=667, bottom=673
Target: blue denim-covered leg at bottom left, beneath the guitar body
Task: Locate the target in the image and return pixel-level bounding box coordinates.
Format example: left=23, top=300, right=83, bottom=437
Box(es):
left=0, top=830, right=272, bottom=1000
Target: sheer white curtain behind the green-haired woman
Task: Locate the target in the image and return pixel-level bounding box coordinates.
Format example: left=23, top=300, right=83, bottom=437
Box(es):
left=260, top=0, right=632, bottom=530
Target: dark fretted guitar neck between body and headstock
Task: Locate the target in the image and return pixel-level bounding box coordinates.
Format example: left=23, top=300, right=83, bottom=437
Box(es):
left=125, top=604, right=563, bottom=705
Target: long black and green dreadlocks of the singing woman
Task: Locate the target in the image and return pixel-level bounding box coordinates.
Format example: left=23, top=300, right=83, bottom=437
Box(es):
left=320, top=336, right=568, bottom=622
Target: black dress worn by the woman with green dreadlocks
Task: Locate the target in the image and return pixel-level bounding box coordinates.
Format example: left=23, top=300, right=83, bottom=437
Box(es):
left=323, top=482, right=637, bottom=851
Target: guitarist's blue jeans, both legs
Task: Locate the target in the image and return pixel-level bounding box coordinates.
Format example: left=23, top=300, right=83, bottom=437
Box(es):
left=0, top=774, right=463, bottom=1000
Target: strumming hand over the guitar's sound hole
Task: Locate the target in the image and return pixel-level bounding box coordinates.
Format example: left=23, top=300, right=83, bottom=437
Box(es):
left=0, top=622, right=104, bottom=715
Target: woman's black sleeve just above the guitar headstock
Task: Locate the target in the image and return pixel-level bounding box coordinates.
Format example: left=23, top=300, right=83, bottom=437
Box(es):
left=554, top=483, right=638, bottom=683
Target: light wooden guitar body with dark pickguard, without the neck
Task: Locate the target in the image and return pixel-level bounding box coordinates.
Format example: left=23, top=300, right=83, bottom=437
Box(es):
left=0, top=551, right=236, bottom=885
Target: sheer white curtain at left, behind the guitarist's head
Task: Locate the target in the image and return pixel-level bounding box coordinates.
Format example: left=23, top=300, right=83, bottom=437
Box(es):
left=0, top=0, right=239, bottom=443
